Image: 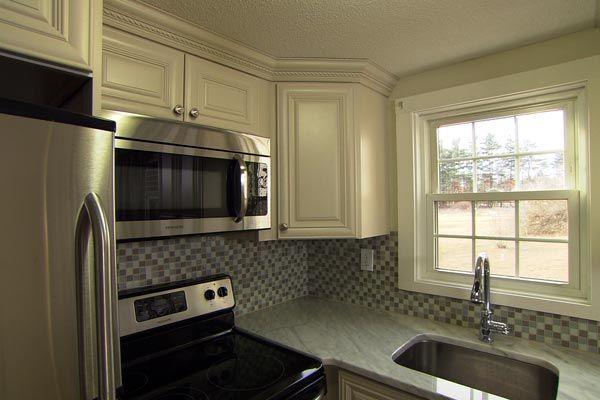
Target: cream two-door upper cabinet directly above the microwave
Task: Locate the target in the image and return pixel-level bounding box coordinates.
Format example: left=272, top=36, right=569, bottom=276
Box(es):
left=102, top=27, right=272, bottom=136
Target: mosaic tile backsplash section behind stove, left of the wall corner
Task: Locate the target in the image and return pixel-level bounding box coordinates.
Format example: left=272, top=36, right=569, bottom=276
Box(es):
left=117, top=235, right=308, bottom=314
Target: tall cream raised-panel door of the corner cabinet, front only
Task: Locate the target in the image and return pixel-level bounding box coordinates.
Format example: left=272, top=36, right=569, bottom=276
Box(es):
left=277, top=83, right=356, bottom=238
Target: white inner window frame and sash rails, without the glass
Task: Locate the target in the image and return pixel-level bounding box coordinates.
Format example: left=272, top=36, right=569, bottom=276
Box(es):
left=421, top=101, right=587, bottom=298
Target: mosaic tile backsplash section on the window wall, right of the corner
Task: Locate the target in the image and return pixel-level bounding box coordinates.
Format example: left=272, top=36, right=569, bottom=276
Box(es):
left=307, top=233, right=600, bottom=353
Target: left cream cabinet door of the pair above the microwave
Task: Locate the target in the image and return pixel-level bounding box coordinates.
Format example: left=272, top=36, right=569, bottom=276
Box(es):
left=102, top=26, right=185, bottom=121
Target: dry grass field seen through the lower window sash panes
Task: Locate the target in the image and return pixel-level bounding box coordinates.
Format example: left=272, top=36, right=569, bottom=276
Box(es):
left=438, top=205, right=568, bottom=282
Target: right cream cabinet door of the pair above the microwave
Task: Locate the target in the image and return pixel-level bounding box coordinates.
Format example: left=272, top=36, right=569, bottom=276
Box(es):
left=185, top=55, right=270, bottom=136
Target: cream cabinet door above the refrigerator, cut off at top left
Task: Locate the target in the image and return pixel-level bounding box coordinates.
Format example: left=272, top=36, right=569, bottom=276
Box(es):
left=0, top=0, right=92, bottom=71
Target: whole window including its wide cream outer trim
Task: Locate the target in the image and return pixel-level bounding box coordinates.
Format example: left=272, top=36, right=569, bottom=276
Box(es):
left=396, top=68, right=600, bottom=318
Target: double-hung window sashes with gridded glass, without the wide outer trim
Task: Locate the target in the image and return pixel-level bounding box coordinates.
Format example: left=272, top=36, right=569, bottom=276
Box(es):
left=428, top=107, right=579, bottom=284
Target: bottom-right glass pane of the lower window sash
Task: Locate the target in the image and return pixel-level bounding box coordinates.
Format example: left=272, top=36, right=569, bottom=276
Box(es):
left=519, top=242, right=569, bottom=282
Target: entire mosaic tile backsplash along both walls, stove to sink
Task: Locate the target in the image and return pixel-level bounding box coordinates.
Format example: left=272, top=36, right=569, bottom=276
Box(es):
left=117, top=233, right=600, bottom=353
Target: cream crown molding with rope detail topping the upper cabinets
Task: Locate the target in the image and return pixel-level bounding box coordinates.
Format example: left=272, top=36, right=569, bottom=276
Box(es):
left=103, top=0, right=398, bottom=96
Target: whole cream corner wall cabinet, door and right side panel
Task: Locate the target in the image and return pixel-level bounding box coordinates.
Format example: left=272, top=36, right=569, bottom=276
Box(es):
left=277, top=83, right=389, bottom=239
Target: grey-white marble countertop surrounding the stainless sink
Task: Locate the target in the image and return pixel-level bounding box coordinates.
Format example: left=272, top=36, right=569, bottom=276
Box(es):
left=236, top=297, right=600, bottom=400
